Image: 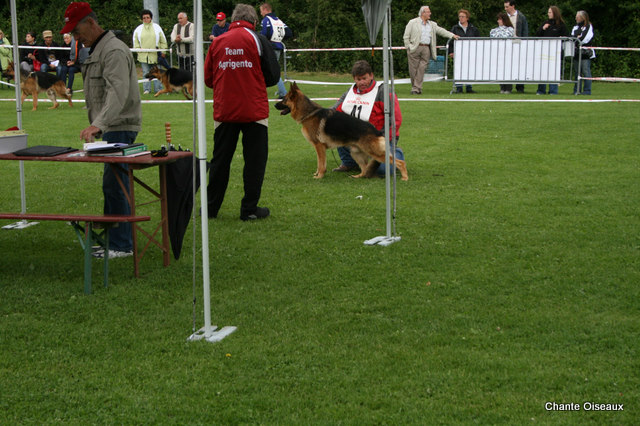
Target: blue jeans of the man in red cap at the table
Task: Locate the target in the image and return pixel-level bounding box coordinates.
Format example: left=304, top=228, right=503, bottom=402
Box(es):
left=102, top=131, right=138, bottom=251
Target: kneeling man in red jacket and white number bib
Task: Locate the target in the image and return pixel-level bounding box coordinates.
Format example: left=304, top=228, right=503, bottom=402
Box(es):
left=333, top=61, right=404, bottom=176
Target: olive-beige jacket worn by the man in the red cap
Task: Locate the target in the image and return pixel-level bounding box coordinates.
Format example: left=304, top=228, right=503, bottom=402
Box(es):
left=82, top=31, right=142, bottom=133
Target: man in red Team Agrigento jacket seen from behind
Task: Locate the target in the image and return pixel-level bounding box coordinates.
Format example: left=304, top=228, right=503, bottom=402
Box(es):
left=204, top=4, right=280, bottom=221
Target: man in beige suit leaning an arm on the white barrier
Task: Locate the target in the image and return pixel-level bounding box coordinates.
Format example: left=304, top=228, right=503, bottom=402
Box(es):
left=402, top=6, right=460, bottom=95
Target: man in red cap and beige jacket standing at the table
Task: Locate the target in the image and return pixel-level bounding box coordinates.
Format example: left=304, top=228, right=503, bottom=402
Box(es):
left=60, top=2, right=142, bottom=258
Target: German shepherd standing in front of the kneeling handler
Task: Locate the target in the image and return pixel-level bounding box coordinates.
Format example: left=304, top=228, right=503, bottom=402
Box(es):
left=275, top=82, right=409, bottom=180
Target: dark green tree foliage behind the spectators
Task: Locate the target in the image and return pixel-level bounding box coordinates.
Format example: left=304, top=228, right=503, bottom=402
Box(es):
left=0, top=0, right=640, bottom=77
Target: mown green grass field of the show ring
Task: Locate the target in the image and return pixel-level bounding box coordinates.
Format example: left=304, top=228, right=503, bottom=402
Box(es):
left=0, top=74, right=640, bottom=425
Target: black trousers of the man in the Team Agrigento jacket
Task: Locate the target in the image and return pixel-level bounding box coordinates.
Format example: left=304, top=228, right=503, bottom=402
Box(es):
left=207, top=123, right=269, bottom=216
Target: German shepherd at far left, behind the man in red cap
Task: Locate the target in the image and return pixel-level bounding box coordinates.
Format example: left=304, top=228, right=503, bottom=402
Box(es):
left=2, top=62, right=73, bottom=111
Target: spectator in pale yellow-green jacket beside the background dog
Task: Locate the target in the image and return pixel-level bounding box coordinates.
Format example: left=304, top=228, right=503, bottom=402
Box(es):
left=133, top=9, right=168, bottom=95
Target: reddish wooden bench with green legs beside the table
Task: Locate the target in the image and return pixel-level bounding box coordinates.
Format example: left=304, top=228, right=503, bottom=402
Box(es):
left=0, top=213, right=151, bottom=294
